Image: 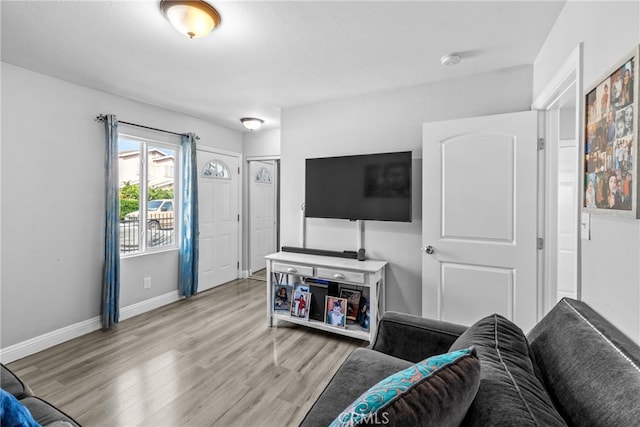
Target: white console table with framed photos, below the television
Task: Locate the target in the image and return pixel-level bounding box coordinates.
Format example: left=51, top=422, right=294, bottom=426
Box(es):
left=265, top=252, right=387, bottom=342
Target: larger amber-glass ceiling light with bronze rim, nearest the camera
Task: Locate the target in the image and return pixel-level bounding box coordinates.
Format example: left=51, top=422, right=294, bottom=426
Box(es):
left=160, top=0, right=220, bottom=39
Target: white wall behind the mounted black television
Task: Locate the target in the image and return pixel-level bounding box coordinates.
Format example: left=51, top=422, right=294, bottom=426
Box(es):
left=280, top=64, right=532, bottom=315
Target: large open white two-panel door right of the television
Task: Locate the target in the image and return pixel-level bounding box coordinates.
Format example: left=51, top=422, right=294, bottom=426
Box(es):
left=422, top=111, right=539, bottom=332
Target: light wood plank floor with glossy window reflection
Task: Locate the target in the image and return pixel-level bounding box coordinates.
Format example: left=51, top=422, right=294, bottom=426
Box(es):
left=8, top=279, right=367, bottom=427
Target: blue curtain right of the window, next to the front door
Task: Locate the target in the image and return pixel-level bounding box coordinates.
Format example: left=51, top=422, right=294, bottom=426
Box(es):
left=178, top=133, right=199, bottom=298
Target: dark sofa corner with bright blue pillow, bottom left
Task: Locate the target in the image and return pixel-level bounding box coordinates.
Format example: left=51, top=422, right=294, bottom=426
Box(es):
left=0, top=364, right=80, bottom=427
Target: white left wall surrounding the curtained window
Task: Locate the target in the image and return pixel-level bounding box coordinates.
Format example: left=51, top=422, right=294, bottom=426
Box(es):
left=0, top=63, right=242, bottom=349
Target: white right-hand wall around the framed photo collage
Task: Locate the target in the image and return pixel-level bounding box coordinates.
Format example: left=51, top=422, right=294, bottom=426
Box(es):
left=533, top=1, right=640, bottom=342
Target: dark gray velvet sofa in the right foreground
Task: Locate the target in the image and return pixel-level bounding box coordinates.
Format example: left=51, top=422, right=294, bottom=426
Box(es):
left=301, top=298, right=640, bottom=427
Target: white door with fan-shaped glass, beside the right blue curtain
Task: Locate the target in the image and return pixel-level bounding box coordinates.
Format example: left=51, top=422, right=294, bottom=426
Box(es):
left=198, top=150, right=240, bottom=291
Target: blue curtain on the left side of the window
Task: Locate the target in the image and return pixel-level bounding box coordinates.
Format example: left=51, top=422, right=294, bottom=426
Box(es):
left=102, top=114, right=120, bottom=329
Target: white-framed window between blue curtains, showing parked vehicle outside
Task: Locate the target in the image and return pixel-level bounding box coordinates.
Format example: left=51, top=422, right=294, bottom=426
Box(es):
left=118, top=134, right=179, bottom=255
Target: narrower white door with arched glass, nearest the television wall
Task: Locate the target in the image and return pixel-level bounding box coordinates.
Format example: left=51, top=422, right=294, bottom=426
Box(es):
left=249, top=161, right=277, bottom=274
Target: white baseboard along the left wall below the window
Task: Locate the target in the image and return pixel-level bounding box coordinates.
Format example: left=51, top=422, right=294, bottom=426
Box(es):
left=0, top=290, right=182, bottom=363
